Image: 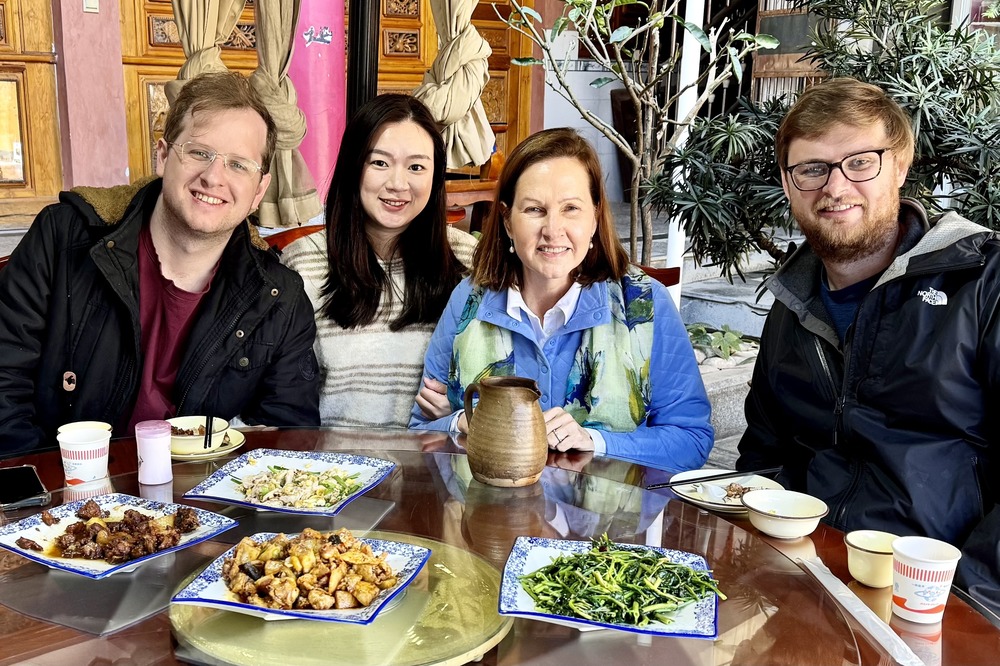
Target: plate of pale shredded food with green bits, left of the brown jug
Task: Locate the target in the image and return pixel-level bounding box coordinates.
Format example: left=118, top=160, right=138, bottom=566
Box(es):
left=184, top=449, right=396, bottom=516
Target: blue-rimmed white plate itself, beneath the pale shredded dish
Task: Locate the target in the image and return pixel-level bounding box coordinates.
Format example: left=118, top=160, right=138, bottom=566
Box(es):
left=184, top=449, right=396, bottom=516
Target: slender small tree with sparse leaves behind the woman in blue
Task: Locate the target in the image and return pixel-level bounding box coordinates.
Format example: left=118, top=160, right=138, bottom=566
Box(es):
left=498, top=0, right=778, bottom=264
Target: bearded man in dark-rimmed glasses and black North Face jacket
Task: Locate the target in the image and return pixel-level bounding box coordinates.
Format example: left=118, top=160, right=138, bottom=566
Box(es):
left=736, top=78, right=1000, bottom=608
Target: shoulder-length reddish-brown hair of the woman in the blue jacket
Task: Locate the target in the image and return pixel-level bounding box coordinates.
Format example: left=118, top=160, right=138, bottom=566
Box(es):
left=472, top=127, right=629, bottom=291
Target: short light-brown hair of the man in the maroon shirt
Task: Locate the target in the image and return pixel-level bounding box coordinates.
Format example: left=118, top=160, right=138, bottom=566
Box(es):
left=163, top=72, right=278, bottom=173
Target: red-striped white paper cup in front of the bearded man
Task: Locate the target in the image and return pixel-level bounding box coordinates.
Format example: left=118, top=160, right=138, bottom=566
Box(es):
left=892, top=537, right=962, bottom=624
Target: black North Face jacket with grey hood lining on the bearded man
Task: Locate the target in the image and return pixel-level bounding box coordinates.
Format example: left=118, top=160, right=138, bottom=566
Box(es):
left=737, top=200, right=1000, bottom=546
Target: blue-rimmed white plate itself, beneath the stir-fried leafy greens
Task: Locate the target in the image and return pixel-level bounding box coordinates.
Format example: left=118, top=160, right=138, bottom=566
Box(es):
left=499, top=537, right=719, bottom=638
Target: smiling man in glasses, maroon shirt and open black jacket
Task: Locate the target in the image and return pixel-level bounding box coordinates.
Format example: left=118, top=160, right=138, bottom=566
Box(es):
left=0, top=72, right=319, bottom=457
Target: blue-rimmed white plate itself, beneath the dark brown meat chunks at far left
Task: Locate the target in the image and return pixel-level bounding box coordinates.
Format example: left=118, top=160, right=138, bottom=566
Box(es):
left=0, top=493, right=236, bottom=580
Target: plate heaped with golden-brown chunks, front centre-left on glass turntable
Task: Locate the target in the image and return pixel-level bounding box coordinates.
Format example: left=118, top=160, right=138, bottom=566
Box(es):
left=171, top=528, right=430, bottom=624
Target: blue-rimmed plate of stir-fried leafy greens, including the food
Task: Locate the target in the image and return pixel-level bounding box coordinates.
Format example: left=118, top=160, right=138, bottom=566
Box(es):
left=499, top=535, right=726, bottom=638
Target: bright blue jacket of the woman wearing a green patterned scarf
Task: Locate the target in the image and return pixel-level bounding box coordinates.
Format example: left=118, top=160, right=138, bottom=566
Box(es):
left=410, top=279, right=713, bottom=471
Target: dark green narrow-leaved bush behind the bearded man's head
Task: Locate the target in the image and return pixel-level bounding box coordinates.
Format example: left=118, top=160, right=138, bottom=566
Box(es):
left=644, top=0, right=1000, bottom=280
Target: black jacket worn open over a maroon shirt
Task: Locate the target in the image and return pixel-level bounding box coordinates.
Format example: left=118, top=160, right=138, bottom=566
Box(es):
left=0, top=179, right=319, bottom=456
